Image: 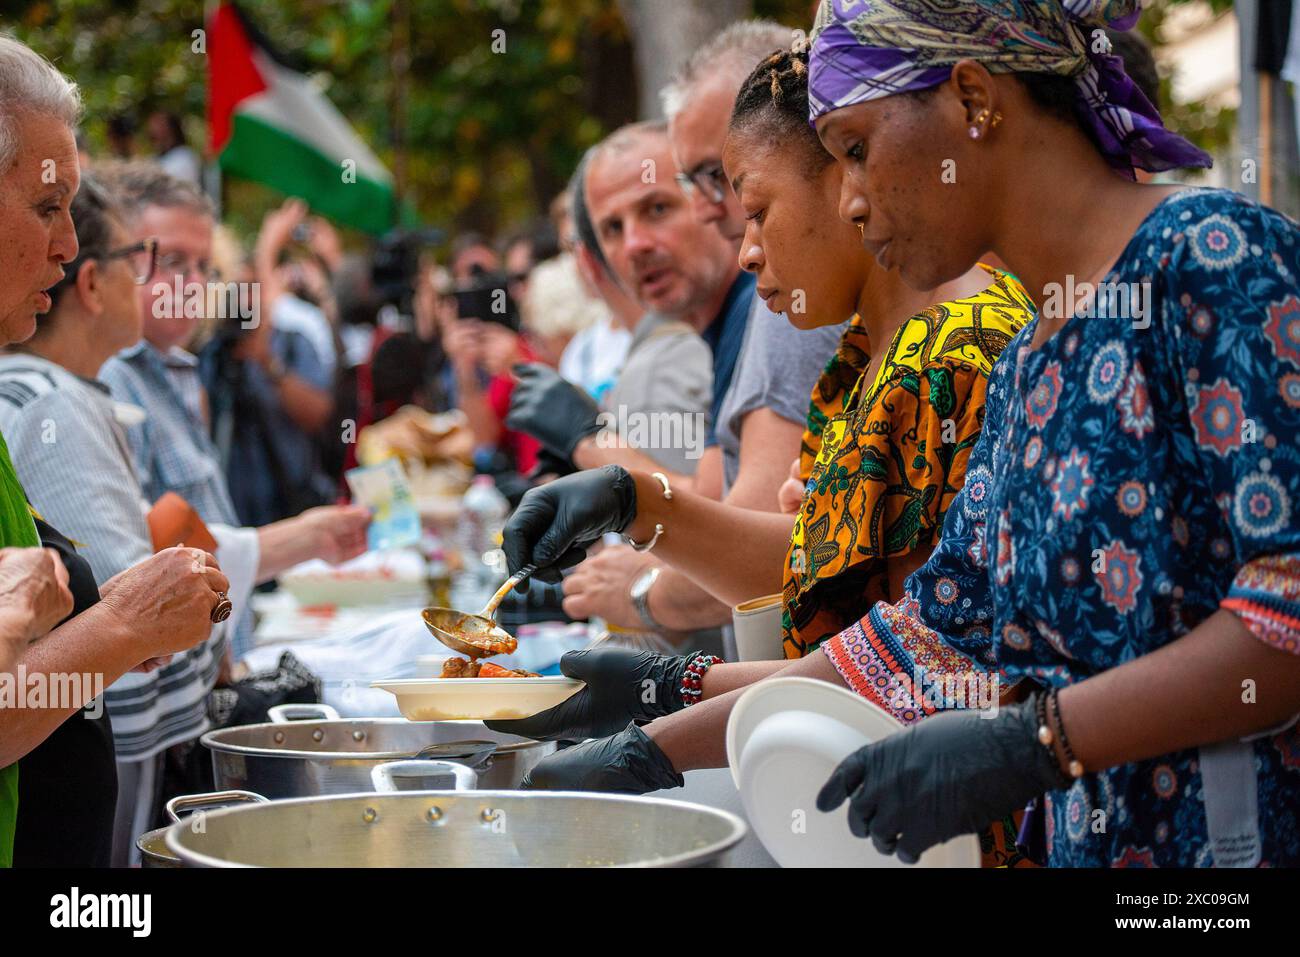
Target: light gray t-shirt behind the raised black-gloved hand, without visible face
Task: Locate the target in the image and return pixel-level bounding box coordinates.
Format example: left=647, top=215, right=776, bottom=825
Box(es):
left=597, top=313, right=712, bottom=475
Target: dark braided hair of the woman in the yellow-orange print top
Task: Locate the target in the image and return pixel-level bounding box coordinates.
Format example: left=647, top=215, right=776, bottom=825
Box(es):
left=731, top=49, right=832, bottom=170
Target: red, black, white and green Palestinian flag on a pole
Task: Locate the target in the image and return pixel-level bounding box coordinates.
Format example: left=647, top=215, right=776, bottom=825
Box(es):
left=207, top=3, right=399, bottom=234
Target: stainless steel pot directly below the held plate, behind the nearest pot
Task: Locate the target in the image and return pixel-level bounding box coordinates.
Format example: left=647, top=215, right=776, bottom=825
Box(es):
left=200, top=705, right=555, bottom=798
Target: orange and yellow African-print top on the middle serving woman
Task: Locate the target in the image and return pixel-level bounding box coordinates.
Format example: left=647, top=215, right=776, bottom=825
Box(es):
left=781, top=267, right=1034, bottom=658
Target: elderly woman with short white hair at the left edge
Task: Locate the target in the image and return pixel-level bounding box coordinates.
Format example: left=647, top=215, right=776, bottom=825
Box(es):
left=0, top=35, right=229, bottom=866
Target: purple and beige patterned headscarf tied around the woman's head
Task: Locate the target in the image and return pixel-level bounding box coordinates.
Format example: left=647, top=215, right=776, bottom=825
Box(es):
left=809, top=0, right=1213, bottom=173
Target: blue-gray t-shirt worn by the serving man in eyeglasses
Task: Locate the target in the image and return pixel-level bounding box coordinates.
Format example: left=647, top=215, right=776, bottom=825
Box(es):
left=714, top=296, right=848, bottom=494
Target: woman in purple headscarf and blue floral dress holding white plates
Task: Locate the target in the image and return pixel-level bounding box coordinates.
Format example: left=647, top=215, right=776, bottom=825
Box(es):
left=810, top=0, right=1300, bottom=866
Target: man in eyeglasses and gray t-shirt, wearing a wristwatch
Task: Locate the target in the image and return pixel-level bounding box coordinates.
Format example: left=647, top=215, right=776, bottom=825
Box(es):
left=551, top=20, right=842, bottom=647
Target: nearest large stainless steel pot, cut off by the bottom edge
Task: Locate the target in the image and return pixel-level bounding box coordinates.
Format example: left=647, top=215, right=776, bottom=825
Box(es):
left=166, top=791, right=746, bottom=867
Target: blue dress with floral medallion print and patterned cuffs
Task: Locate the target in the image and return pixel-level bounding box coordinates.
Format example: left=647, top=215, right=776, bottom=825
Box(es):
left=824, top=190, right=1300, bottom=866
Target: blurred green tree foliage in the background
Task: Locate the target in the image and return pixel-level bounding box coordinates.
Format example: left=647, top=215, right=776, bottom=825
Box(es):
left=4, top=0, right=1234, bottom=234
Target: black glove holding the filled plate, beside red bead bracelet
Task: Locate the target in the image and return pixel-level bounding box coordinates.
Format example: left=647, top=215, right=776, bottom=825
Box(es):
left=486, top=645, right=696, bottom=741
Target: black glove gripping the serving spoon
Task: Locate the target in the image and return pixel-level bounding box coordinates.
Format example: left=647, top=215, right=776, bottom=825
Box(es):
left=502, top=465, right=637, bottom=584
